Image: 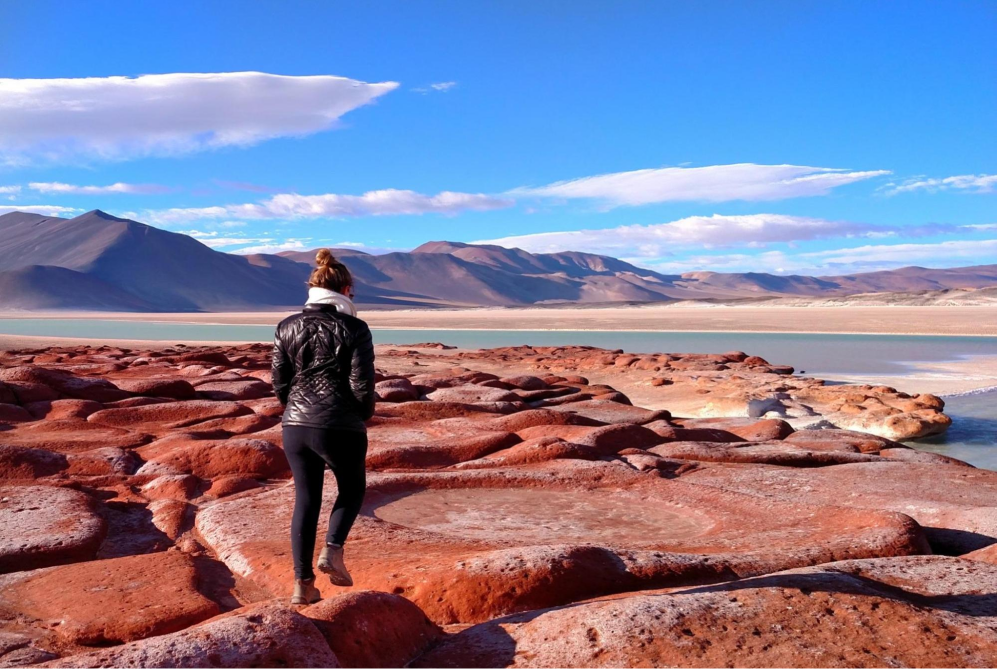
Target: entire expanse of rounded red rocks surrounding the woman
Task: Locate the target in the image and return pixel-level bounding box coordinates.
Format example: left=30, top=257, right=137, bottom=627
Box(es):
left=0, top=345, right=996, bottom=669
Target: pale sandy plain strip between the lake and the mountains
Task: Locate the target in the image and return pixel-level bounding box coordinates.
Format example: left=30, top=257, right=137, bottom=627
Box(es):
left=0, top=304, right=997, bottom=336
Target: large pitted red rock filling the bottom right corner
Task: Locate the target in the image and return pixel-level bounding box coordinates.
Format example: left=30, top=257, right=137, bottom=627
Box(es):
left=409, top=556, right=997, bottom=669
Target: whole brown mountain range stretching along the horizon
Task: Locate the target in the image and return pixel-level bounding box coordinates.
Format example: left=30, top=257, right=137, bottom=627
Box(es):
left=0, top=210, right=996, bottom=312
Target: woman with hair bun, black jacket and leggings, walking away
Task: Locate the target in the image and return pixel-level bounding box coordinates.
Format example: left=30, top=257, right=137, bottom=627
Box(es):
left=271, top=249, right=375, bottom=604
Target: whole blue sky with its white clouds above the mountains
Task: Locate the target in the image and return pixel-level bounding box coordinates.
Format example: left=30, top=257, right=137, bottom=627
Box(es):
left=0, top=0, right=997, bottom=274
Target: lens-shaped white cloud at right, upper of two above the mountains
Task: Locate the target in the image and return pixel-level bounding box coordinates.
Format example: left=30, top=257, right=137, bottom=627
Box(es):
left=510, top=163, right=890, bottom=207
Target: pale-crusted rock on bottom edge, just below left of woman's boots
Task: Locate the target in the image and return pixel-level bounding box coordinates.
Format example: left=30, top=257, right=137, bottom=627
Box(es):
left=38, top=605, right=341, bottom=669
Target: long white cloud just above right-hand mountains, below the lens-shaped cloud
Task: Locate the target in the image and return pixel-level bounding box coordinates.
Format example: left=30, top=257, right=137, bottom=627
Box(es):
left=474, top=214, right=944, bottom=258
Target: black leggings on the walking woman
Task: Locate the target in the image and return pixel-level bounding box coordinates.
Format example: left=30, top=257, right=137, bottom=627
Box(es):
left=281, top=425, right=368, bottom=579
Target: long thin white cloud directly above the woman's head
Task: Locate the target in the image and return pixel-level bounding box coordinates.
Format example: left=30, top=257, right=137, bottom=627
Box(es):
left=138, top=189, right=514, bottom=224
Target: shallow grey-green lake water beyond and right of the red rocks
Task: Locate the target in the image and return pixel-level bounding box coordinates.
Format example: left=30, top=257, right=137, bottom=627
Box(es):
left=0, top=314, right=997, bottom=470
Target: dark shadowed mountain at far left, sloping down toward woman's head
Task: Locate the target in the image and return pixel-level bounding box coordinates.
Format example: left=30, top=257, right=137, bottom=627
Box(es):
left=0, top=211, right=308, bottom=311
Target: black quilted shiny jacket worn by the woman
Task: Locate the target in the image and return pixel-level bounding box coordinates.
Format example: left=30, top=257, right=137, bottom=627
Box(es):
left=271, top=304, right=375, bottom=431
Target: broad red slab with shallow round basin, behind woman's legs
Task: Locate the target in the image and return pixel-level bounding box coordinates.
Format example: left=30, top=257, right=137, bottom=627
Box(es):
left=196, top=460, right=927, bottom=624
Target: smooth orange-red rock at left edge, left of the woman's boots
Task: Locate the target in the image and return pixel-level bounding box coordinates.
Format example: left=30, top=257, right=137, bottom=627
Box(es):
left=0, top=551, right=219, bottom=645
